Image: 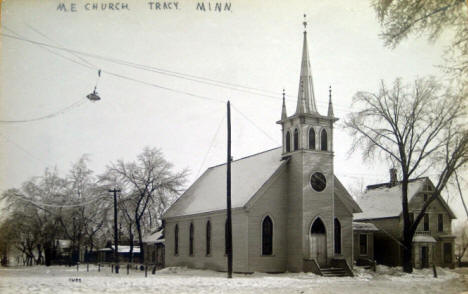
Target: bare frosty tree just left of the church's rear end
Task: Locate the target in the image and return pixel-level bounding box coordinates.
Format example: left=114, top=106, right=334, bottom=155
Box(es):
left=101, top=147, right=187, bottom=259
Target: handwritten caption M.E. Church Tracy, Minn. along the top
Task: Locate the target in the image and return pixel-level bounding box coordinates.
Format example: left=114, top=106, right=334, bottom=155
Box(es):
left=57, top=1, right=232, bottom=12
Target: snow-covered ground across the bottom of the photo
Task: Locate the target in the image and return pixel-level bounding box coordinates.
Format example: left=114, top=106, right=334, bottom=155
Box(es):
left=0, top=265, right=468, bottom=294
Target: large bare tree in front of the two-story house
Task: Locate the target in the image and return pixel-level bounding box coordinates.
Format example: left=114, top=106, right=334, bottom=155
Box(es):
left=345, top=78, right=468, bottom=272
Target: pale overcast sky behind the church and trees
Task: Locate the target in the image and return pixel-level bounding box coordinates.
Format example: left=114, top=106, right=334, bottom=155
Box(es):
left=0, top=0, right=464, bottom=224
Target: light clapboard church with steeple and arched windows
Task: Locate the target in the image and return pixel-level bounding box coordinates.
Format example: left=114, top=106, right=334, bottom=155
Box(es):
left=164, top=22, right=361, bottom=272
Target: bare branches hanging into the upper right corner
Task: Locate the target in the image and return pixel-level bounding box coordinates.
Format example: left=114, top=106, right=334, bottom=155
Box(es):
left=372, top=0, right=468, bottom=86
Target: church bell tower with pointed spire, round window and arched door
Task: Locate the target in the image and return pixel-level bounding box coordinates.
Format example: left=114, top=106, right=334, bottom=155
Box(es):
left=277, top=15, right=338, bottom=272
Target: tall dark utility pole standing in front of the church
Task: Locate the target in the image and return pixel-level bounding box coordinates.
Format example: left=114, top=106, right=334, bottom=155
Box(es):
left=226, top=101, right=232, bottom=279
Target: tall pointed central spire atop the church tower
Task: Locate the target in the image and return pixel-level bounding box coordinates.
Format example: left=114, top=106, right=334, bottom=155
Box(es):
left=296, top=14, right=318, bottom=114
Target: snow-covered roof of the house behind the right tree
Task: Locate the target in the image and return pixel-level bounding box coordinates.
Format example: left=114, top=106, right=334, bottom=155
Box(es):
left=354, top=178, right=456, bottom=220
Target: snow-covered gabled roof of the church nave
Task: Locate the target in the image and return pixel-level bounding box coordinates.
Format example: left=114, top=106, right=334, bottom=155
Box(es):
left=164, top=148, right=286, bottom=218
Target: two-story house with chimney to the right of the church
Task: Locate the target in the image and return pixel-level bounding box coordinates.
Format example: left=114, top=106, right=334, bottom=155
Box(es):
left=354, top=169, right=456, bottom=268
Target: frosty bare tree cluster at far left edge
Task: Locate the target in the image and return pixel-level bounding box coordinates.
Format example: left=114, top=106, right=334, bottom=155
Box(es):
left=1, top=156, right=109, bottom=265
